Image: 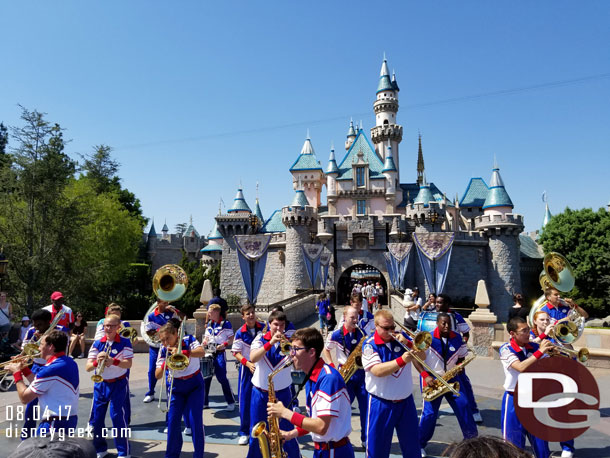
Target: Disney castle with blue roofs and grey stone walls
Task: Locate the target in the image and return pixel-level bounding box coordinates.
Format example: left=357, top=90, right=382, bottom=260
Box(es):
left=158, top=59, right=541, bottom=319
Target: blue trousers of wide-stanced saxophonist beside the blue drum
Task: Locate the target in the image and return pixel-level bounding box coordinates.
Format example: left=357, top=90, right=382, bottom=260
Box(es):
left=419, top=382, right=478, bottom=448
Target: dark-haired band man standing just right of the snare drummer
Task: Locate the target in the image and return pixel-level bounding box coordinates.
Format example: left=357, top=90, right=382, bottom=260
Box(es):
left=231, top=304, right=265, bottom=445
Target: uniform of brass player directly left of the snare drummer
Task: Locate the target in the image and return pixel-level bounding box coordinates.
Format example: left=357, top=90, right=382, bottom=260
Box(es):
left=156, top=334, right=205, bottom=458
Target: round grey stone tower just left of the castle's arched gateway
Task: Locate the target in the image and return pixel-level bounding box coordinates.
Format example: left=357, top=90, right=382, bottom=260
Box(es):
left=282, top=190, right=317, bottom=298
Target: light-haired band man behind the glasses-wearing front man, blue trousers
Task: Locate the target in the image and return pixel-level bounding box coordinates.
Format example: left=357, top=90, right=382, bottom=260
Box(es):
left=323, top=307, right=368, bottom=447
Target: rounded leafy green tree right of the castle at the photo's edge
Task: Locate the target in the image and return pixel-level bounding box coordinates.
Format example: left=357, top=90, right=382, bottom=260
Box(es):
left=540, top=208, right=610, bottom=316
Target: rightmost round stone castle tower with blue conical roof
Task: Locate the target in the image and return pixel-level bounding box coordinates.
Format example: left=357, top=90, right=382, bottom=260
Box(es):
left=474, top=164, right=524, bottom=320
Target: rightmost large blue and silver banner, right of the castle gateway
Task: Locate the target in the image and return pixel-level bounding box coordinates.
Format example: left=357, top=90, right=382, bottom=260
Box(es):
left=413, top=232, right=455, bottom=294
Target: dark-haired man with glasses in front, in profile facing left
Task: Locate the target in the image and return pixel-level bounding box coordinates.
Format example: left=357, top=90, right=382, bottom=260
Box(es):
left=267, top=328, right=354, bottom=458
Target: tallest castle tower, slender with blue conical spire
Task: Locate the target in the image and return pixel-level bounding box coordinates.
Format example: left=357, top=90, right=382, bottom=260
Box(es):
left=371, top=56, right=402, bottom=179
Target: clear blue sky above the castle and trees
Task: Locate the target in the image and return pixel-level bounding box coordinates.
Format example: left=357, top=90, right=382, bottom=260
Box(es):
left=0, top=0, right=610, bottom=234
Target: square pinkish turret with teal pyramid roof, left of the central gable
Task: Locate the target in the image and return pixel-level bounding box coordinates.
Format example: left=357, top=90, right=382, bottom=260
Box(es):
left=290, top=132, right=326, bottom=208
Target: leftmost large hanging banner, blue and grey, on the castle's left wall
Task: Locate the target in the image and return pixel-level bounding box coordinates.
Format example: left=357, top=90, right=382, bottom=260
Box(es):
left=234, top=234, right=271, bottom=304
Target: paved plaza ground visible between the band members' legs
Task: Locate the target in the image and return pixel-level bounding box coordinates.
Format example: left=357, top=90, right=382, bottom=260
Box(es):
left=0, top=314, right=610, bottom=458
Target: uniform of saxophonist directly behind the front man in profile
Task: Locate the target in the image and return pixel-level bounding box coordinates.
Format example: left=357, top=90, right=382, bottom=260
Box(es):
left=247, top=331, right=301, bottom=458
